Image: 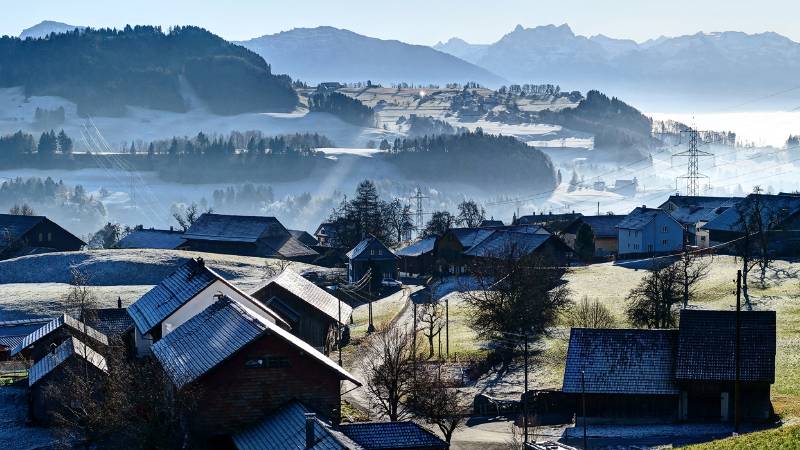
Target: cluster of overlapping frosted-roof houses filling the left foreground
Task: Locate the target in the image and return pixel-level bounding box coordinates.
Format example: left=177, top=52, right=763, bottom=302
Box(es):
left=0, top=258, right=448, bottom=450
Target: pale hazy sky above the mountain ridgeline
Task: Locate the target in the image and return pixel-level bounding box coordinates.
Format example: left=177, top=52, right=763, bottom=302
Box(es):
left=6, top=0, right=800, bottom=44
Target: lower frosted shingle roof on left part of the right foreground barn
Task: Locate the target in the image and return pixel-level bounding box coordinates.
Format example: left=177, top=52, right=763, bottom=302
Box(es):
left=564, top=328, right=680, bottom=394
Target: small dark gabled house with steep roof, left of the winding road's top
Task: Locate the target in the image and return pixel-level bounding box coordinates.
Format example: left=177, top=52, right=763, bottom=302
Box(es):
left=347, top=236, right=399, bottom=292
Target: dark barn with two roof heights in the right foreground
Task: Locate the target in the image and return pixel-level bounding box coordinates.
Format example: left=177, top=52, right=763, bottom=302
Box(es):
left=563, top=309, right=776, bottom=423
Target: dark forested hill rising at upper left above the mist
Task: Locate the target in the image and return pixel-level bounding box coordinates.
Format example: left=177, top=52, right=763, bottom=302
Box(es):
left=0, top=26, right=298, bottom=115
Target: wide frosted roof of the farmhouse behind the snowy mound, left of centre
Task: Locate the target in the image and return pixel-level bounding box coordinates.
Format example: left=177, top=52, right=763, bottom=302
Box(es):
left=184, top=213, right=289, bottom=242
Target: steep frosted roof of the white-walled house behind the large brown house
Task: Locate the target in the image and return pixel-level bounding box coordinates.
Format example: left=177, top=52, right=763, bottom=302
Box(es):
left=128, top=258, right=288, bottom=334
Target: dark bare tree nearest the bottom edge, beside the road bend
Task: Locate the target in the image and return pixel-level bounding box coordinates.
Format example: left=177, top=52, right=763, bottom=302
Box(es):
left=408, top=362, right=465, bottom=444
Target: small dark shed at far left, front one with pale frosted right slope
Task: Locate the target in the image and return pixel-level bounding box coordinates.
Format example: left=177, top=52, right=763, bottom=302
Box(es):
left=28, top=337, right=108, bottom=425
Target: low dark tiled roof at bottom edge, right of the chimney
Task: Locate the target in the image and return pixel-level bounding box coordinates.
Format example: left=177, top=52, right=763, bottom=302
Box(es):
left=339, top=422, right=449, bottom=450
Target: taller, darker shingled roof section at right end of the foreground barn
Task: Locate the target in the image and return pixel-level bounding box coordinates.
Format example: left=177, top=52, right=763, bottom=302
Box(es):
left=676, top=309, right=775, bottom=383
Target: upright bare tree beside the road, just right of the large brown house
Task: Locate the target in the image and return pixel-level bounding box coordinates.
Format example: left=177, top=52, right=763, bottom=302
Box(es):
left=362, top=325, right=414, bottom=421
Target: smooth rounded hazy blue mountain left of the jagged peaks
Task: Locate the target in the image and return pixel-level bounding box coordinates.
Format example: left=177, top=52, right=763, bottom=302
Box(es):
left=234, top=27, right=504, bottom=86
